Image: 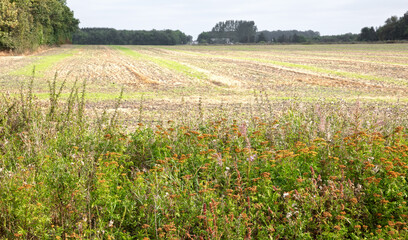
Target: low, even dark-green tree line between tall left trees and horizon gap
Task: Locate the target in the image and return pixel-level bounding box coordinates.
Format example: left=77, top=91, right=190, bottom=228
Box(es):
left=72, top=28, right=192, bottom=45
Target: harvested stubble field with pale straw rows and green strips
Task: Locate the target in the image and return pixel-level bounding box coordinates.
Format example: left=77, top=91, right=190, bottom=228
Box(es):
left=0, top=44, right=408, bottom=122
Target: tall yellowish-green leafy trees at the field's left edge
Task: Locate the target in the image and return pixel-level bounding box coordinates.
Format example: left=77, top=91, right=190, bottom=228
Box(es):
left=0, top=0, right=79, bottom=52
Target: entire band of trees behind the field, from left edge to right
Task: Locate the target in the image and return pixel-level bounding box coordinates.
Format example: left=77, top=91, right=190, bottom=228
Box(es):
left=0, top=5, right=408, bottom=52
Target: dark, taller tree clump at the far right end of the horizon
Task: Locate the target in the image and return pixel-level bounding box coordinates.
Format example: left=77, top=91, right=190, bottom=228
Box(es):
left=359, top=12, right=408, bottom=42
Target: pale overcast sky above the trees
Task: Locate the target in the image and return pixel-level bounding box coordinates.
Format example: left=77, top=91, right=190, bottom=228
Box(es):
left=67, top=0, right=408, bottom=39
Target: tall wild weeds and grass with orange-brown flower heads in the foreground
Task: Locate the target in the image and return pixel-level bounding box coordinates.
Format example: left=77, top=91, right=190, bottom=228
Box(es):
left=0, top=79, right=408, bottom=239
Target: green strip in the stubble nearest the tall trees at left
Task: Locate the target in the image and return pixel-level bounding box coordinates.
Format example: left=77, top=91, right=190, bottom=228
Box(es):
left=10, top=50, right=78, bottom=77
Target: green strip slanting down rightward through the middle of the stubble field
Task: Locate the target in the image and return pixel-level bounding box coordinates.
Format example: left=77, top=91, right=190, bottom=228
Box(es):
left=114, top=46, right=208, bottom=80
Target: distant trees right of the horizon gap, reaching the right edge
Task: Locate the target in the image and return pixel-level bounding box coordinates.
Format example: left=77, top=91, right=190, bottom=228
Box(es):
left=197, top=12, right=408, bottom=44
